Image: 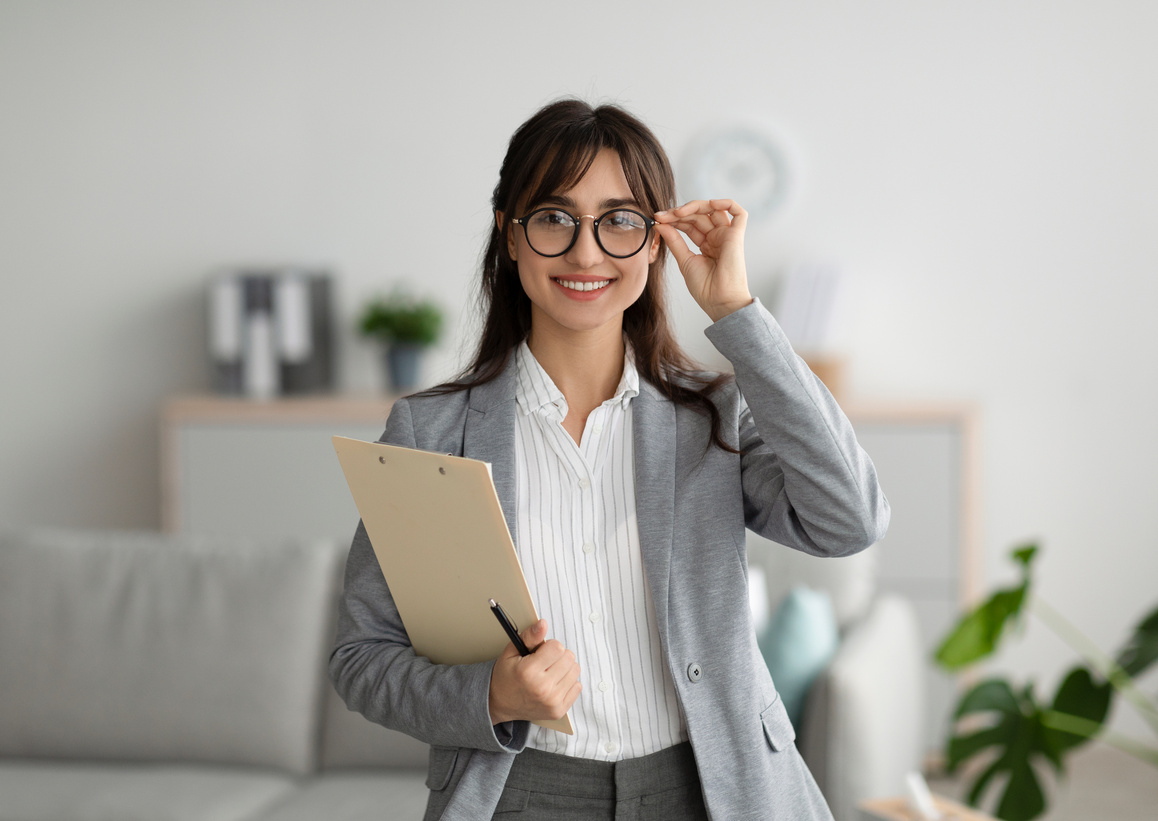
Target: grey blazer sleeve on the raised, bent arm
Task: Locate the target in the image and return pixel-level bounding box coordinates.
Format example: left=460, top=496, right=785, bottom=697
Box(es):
left=705, top=300, right=889, bottom=556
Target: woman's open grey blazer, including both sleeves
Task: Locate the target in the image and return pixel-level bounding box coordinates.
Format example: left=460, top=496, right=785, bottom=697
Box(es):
left=330, top=302, right=889, bottom=821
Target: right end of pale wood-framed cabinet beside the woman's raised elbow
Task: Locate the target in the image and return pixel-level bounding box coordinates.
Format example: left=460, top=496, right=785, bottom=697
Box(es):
left=852, top=412, right=974, bottom=752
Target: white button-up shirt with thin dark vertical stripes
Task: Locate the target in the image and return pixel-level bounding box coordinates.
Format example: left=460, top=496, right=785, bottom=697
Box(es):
left=515, top=343, right=688, bottom=761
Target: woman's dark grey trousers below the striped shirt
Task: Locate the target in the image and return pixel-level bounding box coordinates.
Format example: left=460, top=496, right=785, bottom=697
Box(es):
left=494, top=743, right=708, bottom=821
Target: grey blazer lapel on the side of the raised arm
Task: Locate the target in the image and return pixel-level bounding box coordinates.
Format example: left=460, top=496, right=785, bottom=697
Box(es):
left=631, top=380, right=675, bottom=637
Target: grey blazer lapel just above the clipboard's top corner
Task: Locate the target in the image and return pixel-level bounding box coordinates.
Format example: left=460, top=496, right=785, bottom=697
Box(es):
left=462, top=355, right=516, bottom=540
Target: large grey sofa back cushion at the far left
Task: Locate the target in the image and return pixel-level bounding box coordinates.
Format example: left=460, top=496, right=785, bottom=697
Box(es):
left=0, top=530, right=343, bottom=774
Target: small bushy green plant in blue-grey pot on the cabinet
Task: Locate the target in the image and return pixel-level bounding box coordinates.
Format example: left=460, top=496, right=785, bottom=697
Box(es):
left=358, top=291, right=442, bottom=394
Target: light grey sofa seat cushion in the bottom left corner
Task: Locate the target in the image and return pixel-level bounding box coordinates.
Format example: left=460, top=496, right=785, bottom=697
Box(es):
left=0, top=761, right=294, bottom=821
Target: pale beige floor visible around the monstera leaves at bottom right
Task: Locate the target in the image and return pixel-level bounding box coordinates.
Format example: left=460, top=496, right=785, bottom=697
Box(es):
left=929, top=745, right=1158, bottom=821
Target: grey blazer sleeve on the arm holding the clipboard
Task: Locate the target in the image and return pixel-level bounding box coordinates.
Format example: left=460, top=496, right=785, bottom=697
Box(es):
left=329, top=399, right=529, bottom=753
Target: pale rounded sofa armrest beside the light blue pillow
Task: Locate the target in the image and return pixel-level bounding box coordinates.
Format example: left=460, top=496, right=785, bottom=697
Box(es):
left=798, top=595, right=925, bottom=821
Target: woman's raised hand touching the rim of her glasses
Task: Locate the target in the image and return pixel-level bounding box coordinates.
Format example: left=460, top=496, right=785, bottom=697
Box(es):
left=655, top=199, right=752, bottom=322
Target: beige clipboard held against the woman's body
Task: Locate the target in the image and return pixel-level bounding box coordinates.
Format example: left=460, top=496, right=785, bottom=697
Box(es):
left=332, top=437, right=574, bottom=734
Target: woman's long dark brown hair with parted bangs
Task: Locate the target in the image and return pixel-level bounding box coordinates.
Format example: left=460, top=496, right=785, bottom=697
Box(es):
left=424, top=98, right=735, bottom=453
